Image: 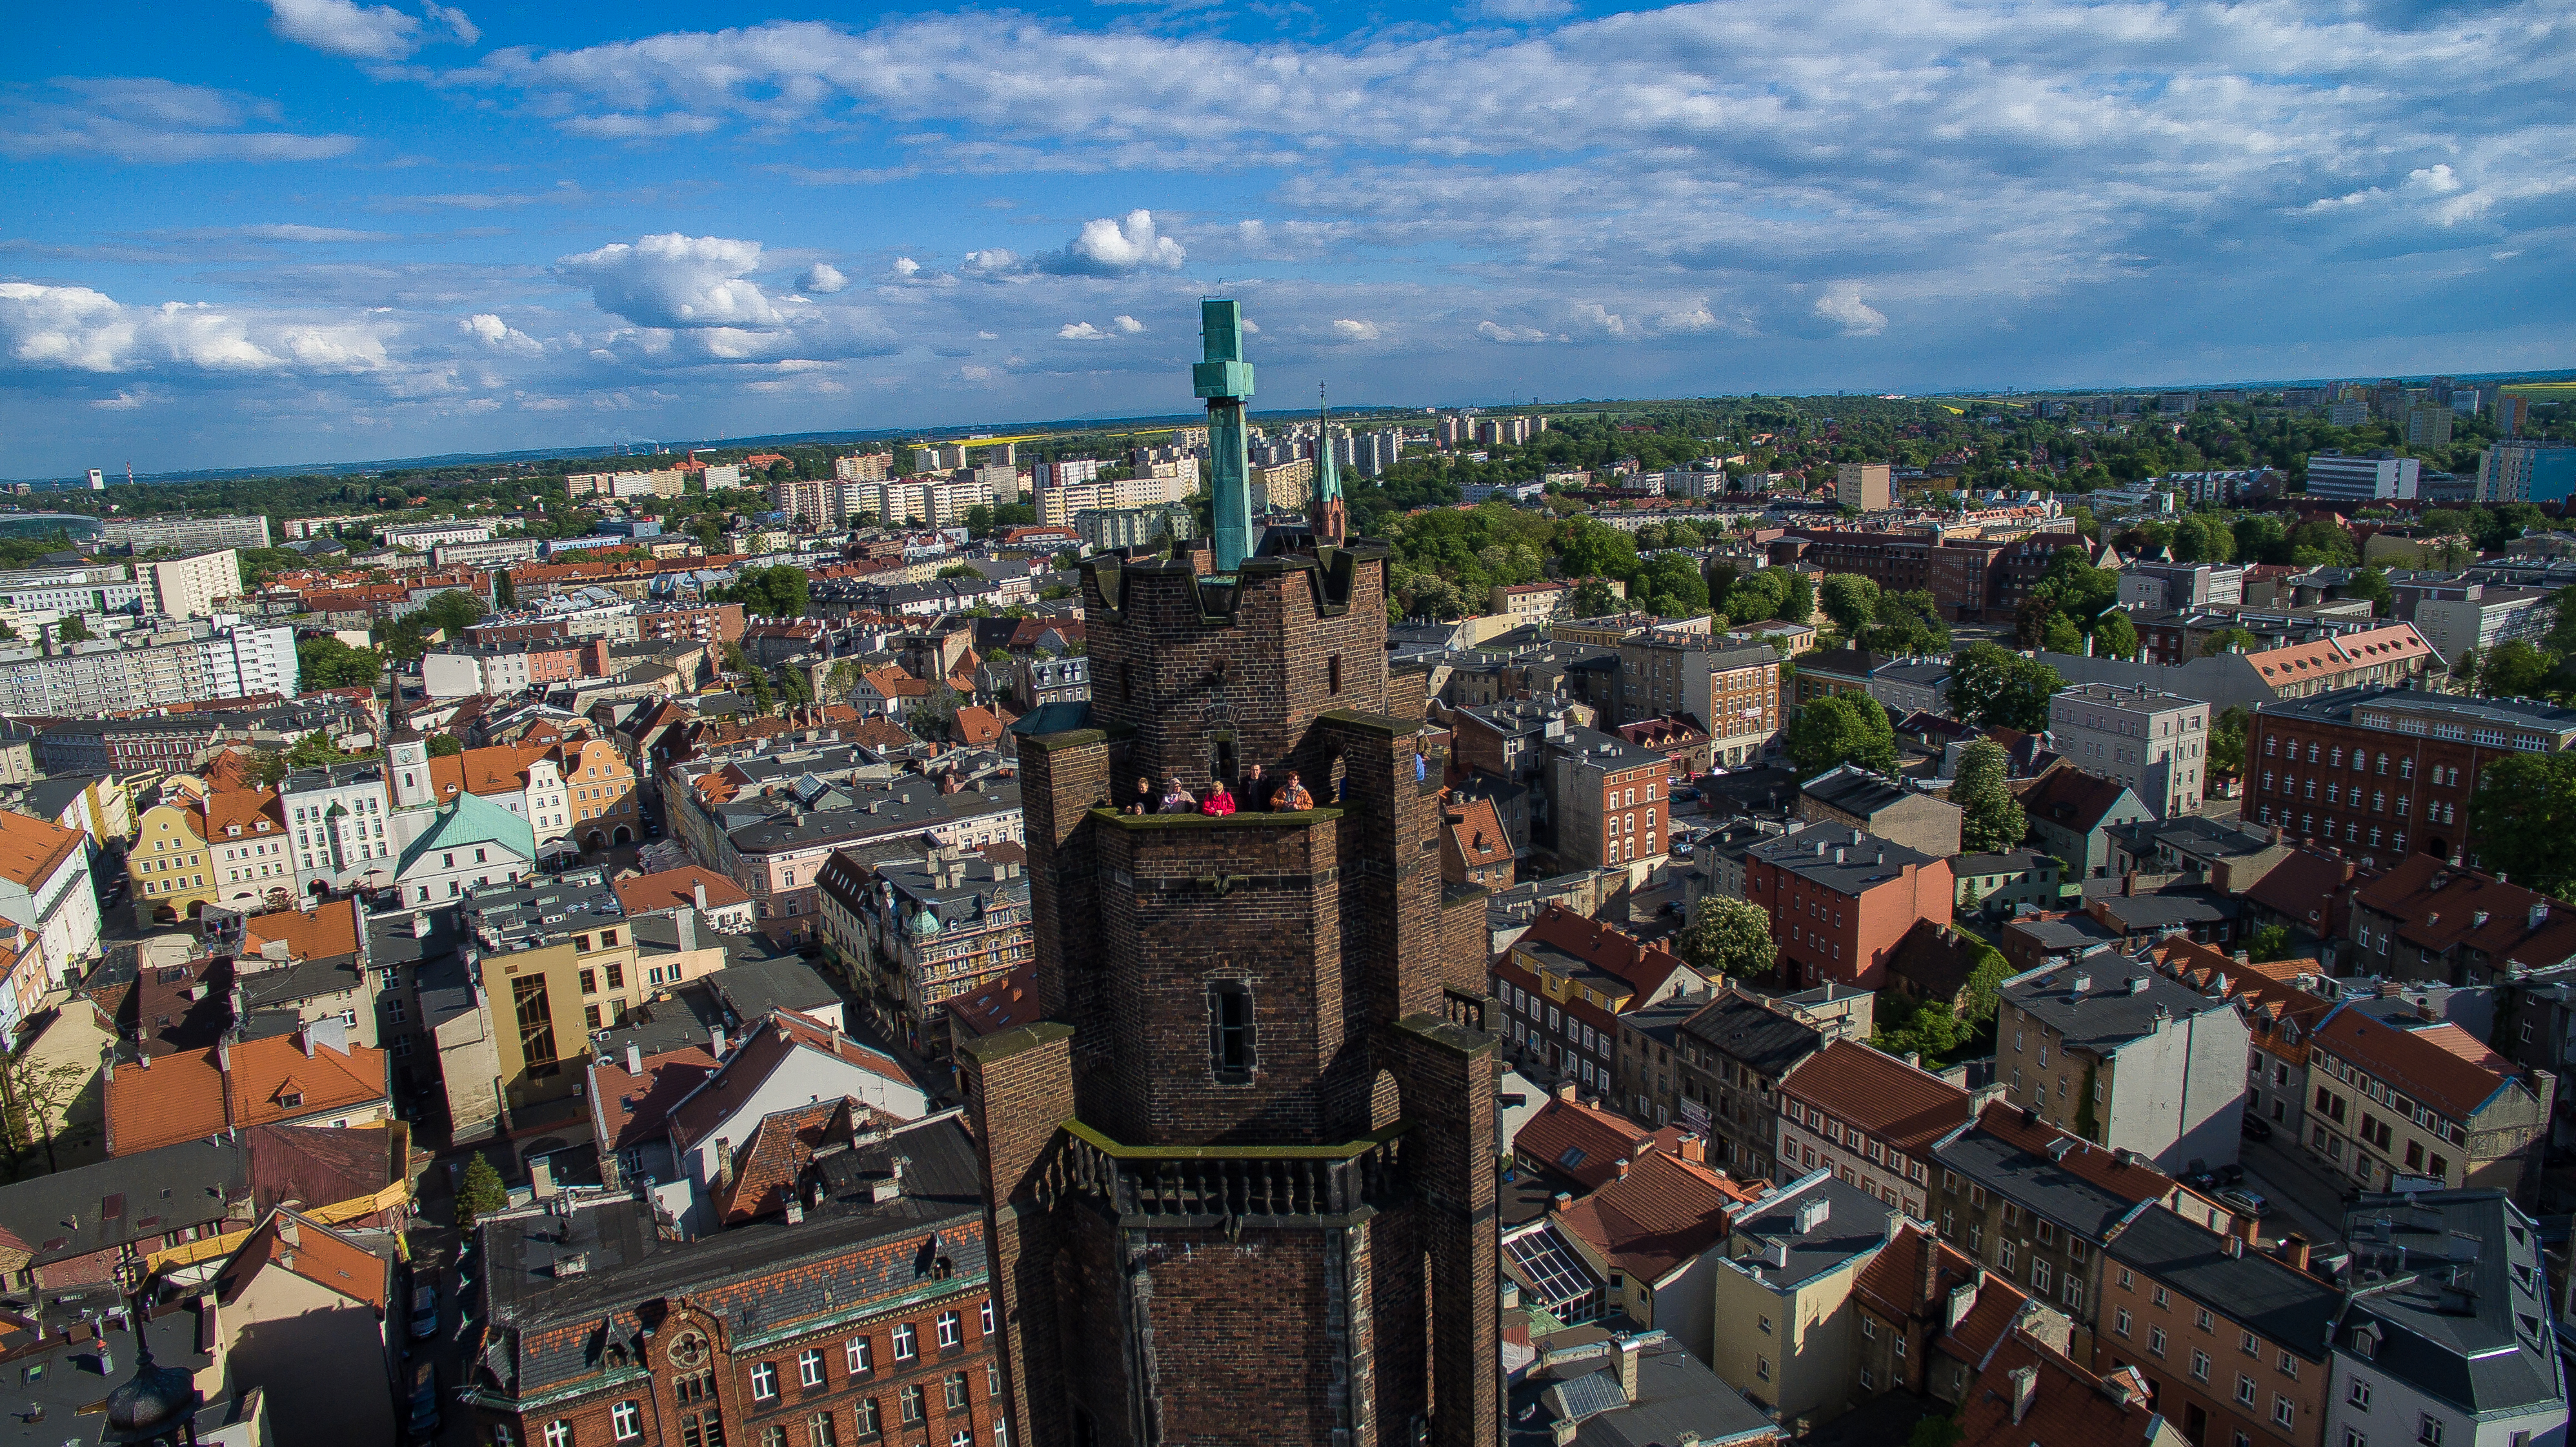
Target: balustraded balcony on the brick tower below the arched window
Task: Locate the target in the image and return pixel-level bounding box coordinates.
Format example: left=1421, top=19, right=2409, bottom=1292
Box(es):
left=1038, top=1120, right=1412, bottom=1226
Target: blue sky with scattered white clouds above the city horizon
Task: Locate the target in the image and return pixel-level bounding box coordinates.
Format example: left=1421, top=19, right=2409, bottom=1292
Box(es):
left=0, top=0, right=2576, bottom=476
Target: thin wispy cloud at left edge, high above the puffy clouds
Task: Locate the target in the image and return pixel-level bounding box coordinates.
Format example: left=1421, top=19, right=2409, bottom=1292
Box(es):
left=0, top=77, right=358, bottom=165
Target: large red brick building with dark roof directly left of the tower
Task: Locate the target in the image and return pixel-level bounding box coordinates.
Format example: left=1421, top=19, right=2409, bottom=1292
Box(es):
left=459, top=1115, right=994, bottom=1447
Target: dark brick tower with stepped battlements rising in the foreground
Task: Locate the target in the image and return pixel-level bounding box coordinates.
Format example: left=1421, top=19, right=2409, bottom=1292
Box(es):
left=958, top=310, right=1499, bottom=1447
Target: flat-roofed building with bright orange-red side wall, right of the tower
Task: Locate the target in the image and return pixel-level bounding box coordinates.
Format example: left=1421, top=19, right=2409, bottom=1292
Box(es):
left=1744, top=824, right=1955, bottom=991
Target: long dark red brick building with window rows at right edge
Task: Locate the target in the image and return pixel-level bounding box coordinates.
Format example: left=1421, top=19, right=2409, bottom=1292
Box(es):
left=2244, top=687, right=2576, bottom=862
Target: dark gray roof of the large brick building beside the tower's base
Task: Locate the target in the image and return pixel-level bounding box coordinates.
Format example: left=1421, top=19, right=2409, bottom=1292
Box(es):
left=474, top=1112, right=987, bottom=1393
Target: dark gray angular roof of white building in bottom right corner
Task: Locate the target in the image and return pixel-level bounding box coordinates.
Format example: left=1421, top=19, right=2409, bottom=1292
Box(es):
left=2334, top=1189, right=2566, bottom=1413
